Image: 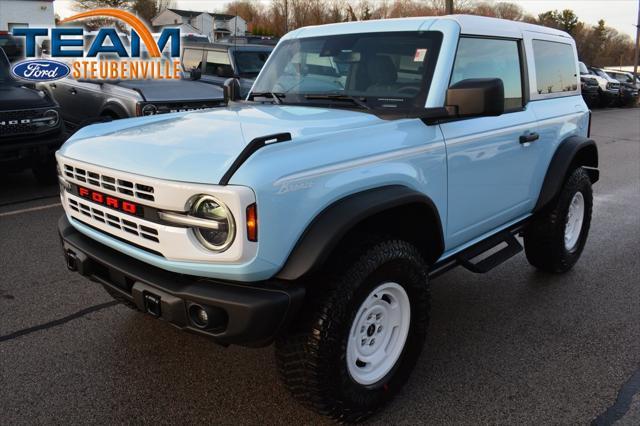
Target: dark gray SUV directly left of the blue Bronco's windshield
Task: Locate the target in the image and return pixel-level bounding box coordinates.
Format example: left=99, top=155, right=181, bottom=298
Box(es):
left=182, top=43, right=273, bottom=98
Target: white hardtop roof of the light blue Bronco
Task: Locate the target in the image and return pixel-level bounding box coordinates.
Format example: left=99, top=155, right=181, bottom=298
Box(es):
left=283, top=15, right=571, bottom=39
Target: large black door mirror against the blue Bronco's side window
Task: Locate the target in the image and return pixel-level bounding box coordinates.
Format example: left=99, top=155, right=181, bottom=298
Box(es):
left=446, top=78, right=504, bottom=117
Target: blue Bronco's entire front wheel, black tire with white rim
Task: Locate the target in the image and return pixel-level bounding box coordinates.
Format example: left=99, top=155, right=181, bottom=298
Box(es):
left=276, top=240, right=429, bottom=422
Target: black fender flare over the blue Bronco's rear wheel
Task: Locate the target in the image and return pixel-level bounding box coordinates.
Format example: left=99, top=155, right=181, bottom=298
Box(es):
left=534, top=136, right=600, bottom=212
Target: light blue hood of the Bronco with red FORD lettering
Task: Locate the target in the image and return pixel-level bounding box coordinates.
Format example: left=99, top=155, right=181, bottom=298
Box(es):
left=60, top=104, right=384, bottom=184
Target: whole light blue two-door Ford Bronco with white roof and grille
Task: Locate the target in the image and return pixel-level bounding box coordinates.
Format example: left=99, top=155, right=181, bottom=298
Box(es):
left=57, top=16, right=598, bottom=421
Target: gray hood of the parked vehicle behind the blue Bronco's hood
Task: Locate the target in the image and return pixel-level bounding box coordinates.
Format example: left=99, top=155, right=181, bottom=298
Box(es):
left=118, top=80, right=224, bottom=102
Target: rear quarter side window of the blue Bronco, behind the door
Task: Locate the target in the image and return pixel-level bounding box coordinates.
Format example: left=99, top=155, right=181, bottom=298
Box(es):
left=533, top=40, right=578, bottom=95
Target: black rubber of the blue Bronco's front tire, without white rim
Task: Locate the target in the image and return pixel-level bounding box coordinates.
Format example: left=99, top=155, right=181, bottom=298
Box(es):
left=276, top=240, right=429, bottom=422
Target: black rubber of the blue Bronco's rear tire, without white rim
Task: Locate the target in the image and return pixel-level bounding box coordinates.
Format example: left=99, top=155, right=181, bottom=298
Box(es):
left=524, top=167, right=593, bottom=273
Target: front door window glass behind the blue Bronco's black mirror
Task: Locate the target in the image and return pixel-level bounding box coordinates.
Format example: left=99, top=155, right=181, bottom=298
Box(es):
left=450, top=37, right=522, bottom=111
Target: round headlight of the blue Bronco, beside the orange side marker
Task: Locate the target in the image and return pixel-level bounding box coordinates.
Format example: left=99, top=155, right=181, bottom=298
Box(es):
left=191, top=195, right=236, bottom=251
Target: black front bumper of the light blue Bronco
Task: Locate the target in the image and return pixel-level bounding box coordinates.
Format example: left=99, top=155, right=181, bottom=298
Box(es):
left=58, top=216, right=305, bottom=346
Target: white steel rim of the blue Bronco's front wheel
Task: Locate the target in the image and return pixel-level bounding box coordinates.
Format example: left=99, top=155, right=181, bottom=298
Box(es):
left=347, top=282, right=411, bottom=386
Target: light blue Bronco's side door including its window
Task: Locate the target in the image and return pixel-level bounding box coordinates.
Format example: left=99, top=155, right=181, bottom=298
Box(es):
left=441, top=36, right=539, bottom=249
